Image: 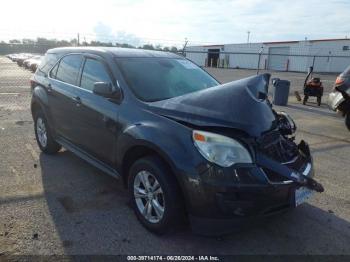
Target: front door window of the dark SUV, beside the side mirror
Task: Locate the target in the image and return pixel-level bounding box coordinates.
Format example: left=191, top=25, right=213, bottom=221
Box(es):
left=80, top=58, right=112, bottom=91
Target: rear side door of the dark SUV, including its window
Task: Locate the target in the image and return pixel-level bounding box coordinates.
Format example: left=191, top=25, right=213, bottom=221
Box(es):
left=48, top=54, right=83, bottom=143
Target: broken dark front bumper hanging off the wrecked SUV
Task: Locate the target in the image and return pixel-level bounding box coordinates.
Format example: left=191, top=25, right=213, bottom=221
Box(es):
left=185, top=141, right=323, bottom=235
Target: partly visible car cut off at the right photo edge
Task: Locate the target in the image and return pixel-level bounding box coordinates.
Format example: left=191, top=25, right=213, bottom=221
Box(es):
left=328, top=66, right=350, bottom=130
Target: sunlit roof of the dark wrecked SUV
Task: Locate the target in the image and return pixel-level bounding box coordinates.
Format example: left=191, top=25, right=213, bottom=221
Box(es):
left=47, top=46, right=183, bottom=58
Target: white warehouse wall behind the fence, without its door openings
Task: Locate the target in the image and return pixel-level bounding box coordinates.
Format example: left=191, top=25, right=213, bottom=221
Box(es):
left=186, top=39, right=350, bottom=73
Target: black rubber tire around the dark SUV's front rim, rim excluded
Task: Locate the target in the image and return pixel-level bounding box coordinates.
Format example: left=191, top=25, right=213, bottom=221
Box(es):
left=128, top=156, right=185, bottom=234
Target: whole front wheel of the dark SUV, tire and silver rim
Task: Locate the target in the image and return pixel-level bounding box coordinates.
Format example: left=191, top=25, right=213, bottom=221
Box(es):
left=128, top=156, right=184, bottom=234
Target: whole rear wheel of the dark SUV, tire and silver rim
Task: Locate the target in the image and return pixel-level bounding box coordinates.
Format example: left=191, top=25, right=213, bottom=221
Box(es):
left=34, top=110, right=61, bottom=154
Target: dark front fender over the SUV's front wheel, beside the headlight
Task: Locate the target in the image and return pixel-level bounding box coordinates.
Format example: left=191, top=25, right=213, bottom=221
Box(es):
left=116, top=122, right=206, bottom=183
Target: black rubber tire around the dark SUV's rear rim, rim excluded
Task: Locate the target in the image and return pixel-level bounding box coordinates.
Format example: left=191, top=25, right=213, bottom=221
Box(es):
left=34, top=110, right=61, bottom=155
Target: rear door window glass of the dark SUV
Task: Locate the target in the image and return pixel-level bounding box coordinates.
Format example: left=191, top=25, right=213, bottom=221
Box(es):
left=56, top=55, right=83, bottom=85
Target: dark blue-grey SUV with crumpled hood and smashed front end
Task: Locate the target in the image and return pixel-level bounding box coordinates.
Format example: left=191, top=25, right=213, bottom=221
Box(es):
left=31, top=47, right=323, bottom=234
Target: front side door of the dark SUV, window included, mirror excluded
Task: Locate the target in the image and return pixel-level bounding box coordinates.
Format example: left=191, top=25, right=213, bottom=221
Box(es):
left=75, top=55, right=119, bottom=165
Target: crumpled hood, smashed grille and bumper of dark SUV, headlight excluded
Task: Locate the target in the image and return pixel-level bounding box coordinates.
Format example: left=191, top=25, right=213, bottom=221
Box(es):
left=149, top=74, right=324, bottom=235
